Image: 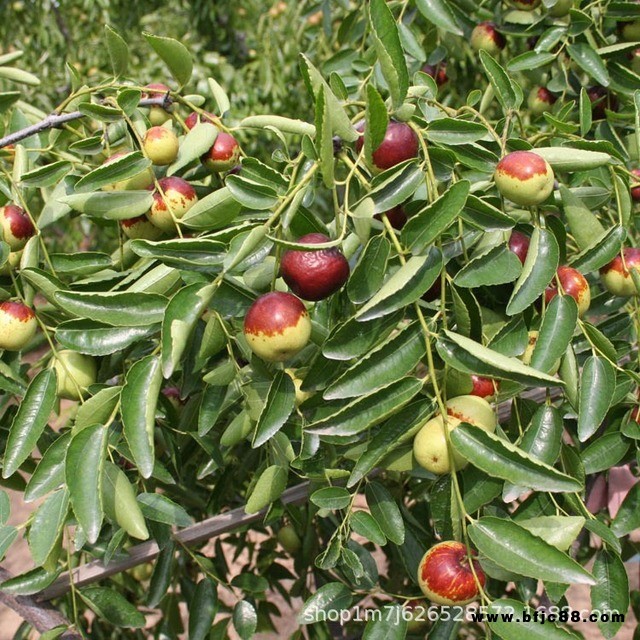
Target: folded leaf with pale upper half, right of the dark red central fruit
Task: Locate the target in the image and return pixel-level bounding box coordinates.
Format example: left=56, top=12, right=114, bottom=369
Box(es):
left=356, top=247, right=442, bottom=322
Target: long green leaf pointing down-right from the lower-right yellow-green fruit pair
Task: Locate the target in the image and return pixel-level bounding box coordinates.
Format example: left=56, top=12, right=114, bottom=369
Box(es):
left=451, top=424, right=582, bottom=493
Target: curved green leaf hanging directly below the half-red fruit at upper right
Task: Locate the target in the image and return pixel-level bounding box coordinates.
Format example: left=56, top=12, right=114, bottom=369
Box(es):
left=507, top=227, right=560, bottom=316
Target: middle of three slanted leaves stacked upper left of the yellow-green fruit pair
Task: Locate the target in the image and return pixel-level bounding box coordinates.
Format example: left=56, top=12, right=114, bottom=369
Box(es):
left=306, top=376, right=422, bottom=437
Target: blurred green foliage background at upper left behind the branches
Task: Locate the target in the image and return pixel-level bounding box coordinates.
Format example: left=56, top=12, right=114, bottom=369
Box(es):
left=0, top=0, right=338, bottom=117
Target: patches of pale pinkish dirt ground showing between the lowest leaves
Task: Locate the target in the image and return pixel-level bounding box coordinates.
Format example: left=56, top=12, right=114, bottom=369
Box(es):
left=0, top=494, right=640, bottom=640
